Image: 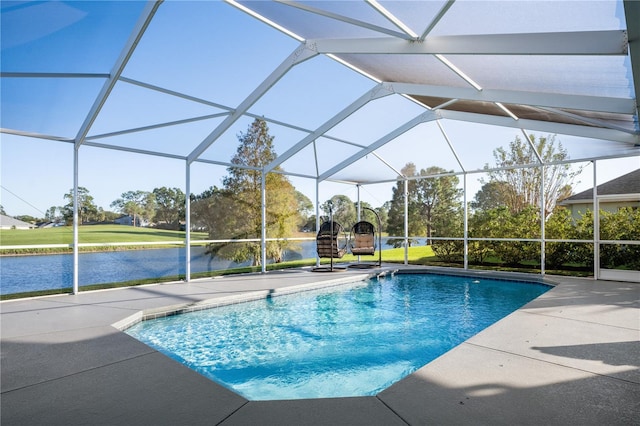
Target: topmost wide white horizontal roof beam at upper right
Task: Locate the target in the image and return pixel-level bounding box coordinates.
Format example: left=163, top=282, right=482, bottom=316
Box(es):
left=309, top=30, right=628, bottom=55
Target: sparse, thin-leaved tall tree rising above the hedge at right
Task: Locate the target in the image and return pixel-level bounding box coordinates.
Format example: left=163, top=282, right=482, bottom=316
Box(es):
left=485, top=134, right=579, bottom=218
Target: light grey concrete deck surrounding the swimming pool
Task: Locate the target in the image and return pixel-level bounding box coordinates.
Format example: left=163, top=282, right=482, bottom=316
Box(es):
left=0, top=265, right=640, bottom=426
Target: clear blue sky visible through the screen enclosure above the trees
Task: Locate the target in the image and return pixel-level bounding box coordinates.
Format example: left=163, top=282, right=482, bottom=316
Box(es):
left=0, top=1, right=640, bottom=217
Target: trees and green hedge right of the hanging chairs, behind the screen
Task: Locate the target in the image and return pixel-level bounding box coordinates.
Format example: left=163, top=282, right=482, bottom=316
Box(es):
left=398, top=135, right=640, bottom=270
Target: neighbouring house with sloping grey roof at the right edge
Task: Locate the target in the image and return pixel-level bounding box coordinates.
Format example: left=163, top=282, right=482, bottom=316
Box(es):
left=559, top=169, right=640, bottom=219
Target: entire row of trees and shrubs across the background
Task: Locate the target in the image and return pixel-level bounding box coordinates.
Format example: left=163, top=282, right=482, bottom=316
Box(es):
left=7, top=119, right=640, bottom=272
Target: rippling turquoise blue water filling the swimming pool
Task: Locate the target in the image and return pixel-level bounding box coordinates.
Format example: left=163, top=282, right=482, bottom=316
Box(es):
left=127, top=274, right=549, bottom=400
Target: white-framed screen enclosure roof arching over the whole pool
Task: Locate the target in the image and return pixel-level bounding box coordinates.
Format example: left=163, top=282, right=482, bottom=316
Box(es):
left=1, top=0, right=640, bottom=184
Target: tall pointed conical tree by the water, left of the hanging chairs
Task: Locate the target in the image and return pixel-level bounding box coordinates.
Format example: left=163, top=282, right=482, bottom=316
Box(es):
left=209, top=119, right=298, bottom=266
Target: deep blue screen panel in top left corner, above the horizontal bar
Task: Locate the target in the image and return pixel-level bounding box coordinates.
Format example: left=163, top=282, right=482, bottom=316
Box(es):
left=1, top=1, right=144, bottom=71
